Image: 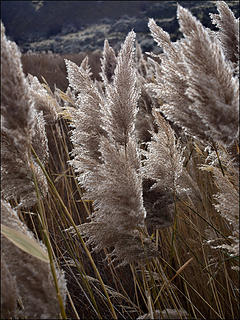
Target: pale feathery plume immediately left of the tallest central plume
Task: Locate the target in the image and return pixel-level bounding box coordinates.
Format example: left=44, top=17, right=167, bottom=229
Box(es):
left=66, top=57, right=105, bottom=172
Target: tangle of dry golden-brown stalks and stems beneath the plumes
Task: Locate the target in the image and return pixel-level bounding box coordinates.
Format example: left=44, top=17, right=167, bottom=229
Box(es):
left=16, top=126, right=236, bottom=319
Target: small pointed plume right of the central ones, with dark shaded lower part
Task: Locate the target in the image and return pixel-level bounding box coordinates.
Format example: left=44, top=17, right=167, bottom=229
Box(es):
left=142, top=111, right=184, bottom=233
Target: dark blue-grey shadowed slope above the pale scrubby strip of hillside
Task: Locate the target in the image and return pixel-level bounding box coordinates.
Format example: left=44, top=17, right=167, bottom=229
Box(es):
left=2, top=1, right=151, bottom=42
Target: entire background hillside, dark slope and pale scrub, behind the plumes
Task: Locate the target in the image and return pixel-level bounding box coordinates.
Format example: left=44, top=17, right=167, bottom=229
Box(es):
left=2, top=1, right=239, bottom=54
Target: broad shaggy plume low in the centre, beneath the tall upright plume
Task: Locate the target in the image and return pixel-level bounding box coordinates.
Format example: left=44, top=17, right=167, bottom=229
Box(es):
left=79, top=138, right=156, bottom=264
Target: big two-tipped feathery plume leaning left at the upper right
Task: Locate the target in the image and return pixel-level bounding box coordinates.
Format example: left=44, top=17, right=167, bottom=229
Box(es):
left=148, top=5, right=239, bottom=145
